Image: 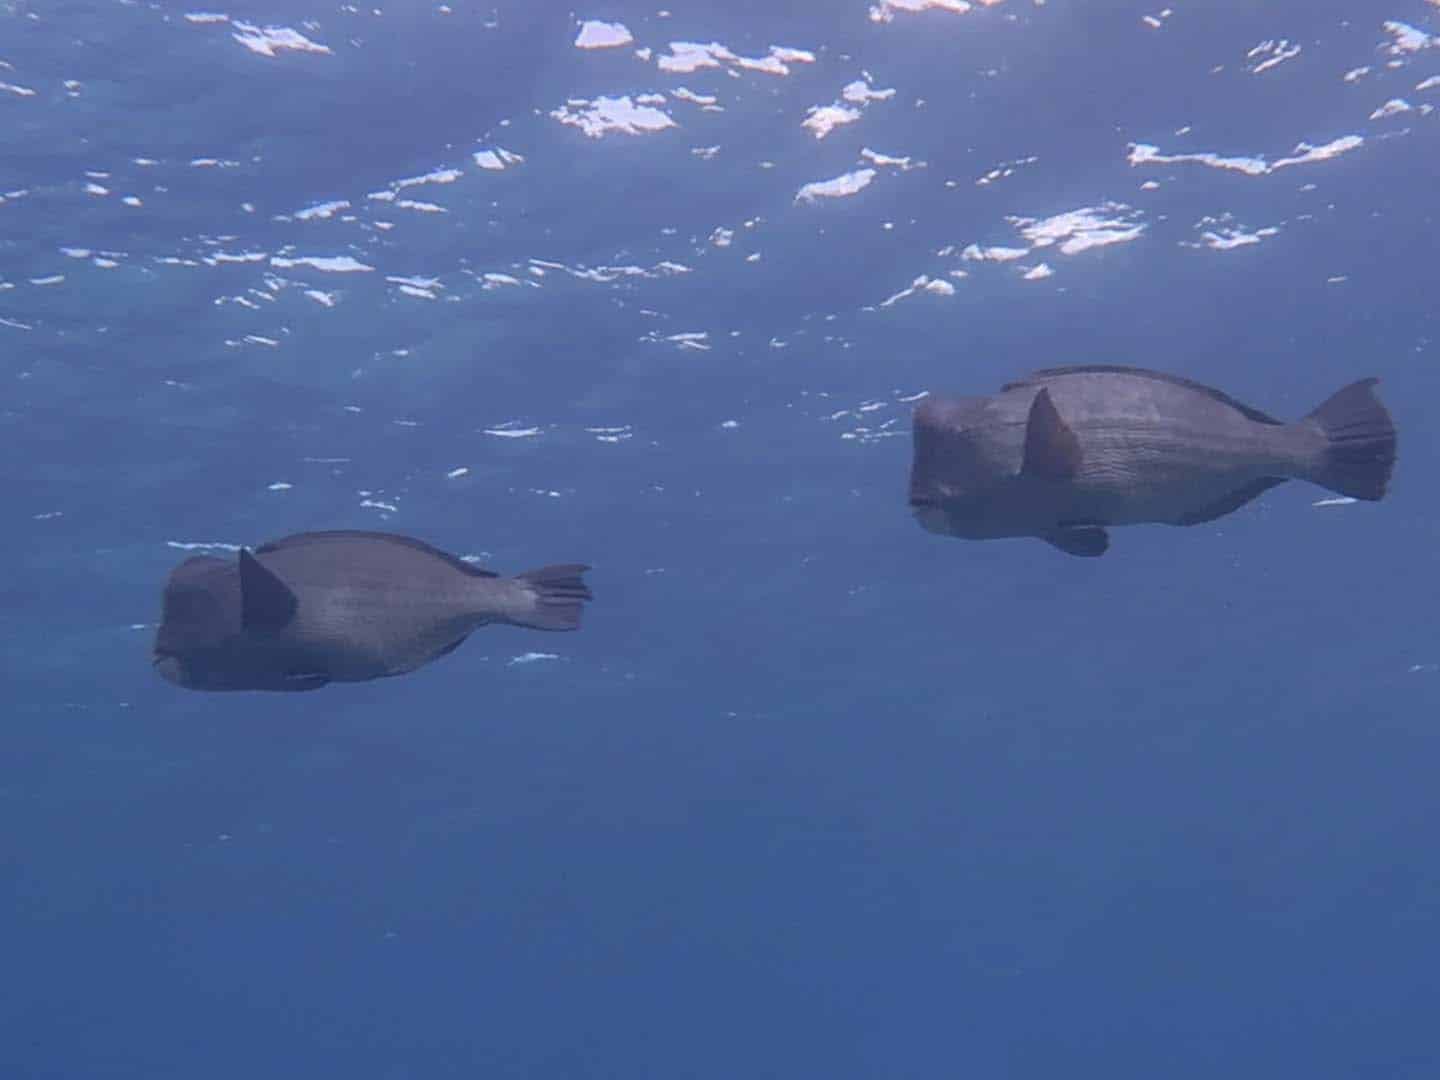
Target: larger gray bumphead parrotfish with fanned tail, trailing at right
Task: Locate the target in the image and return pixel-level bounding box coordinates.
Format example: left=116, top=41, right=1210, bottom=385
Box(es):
left=910, top=366, right=1395, bottom=554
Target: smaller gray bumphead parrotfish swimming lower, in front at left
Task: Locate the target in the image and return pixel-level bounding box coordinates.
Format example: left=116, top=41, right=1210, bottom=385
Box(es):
left=156, top=533, right=589, bottom=690
